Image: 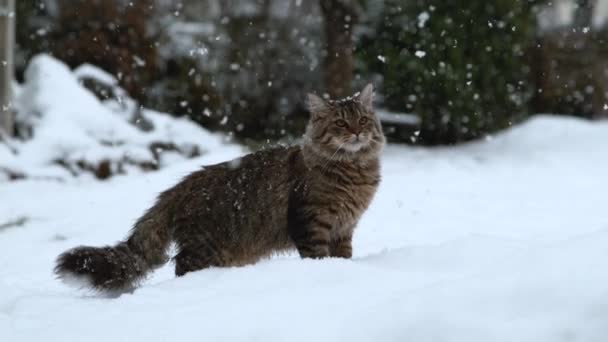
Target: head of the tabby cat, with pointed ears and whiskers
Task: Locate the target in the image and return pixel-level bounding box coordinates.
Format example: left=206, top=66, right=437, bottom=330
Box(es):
left=304, top=84, right=385, bottom=159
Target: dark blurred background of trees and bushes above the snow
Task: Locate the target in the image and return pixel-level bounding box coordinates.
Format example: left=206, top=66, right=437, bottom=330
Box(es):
left=3, top=0, right=608, bottom=145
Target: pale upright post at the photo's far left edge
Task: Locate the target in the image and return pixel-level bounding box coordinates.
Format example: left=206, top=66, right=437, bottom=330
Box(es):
left=0, top=0, right=15, bottom=136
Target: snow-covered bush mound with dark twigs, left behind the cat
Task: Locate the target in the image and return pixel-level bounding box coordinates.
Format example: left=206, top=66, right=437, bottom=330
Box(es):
left=0, top=55, right=236, bottom=180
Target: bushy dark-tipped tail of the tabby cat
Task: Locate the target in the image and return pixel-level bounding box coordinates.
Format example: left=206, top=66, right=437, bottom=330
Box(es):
left=55, top=205, right=172, bottom=293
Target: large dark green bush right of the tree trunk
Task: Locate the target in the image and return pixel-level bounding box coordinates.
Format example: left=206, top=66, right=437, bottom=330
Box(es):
left=358, top=0, right=536, bottom=144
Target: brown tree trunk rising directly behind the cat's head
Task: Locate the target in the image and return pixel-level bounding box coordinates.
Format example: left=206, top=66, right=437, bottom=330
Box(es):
left=321, top=0, right=357, bottom=98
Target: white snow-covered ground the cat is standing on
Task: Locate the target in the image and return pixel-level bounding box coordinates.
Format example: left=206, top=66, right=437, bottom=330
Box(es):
left=0, top=111, right=608, bottom=342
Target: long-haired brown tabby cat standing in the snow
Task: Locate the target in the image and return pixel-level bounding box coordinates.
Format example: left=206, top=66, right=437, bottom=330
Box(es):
left=55, top=84, right=385, bottom=293
